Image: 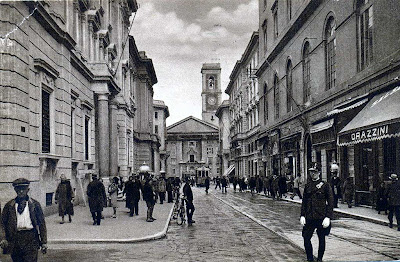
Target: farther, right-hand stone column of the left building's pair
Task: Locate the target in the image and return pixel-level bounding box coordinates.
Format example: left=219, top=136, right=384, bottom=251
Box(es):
left=110, top=102, right=118, bottom=176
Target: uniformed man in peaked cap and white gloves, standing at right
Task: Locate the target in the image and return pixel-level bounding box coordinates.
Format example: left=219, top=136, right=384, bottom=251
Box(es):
left=300, top=167, right=333, bottom=261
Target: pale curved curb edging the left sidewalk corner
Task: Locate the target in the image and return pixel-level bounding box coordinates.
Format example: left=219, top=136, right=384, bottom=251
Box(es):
left=47, top=206, right=174, bottom=244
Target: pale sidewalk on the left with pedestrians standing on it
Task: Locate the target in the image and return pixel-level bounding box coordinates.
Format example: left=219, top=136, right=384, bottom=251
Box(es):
left=46, top=200, right=173, bottom=244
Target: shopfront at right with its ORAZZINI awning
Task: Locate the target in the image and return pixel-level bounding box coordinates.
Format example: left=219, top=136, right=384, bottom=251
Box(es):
left=338, top=86, right=400, bottom=206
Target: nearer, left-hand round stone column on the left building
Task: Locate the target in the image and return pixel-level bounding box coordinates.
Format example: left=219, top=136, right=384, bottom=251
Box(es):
left=97, top=94, right=110, bottom=177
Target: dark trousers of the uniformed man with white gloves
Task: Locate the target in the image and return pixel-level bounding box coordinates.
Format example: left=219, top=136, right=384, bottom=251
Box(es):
left=302, top=219, right=330, bottom=261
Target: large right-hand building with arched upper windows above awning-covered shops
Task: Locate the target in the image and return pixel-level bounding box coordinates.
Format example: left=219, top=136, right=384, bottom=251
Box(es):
left=256, top=0, right=400, bottom=205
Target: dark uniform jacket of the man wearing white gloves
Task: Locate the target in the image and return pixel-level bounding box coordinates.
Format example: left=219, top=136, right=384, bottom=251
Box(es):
left=301, top=180, right=333, bottom=219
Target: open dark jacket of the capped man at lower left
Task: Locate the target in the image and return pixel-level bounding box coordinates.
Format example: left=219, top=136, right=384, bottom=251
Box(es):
left=1, top=198, right=47, bottom=253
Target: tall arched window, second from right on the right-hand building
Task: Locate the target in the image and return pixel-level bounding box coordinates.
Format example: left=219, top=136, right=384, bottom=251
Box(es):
left=325, top=17, right=336, bottom=89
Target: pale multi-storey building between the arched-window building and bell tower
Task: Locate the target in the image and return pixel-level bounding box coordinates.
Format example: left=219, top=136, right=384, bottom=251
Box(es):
left=225, top=32, right=260, bottom=178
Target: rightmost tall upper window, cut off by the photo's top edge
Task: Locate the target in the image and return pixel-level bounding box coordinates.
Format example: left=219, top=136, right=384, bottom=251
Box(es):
left=357, top=0, right=374, bottom=70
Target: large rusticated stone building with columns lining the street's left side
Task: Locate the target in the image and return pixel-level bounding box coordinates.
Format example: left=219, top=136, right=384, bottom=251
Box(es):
left=0, top=0, right=159, bottom=212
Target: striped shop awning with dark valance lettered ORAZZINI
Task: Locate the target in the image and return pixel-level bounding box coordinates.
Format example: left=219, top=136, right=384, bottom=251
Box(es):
left=338, top=86, right=400, bottom=146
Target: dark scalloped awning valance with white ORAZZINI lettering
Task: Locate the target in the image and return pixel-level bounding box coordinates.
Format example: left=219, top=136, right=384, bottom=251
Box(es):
left=338, top=123, right=400, bottom=146
